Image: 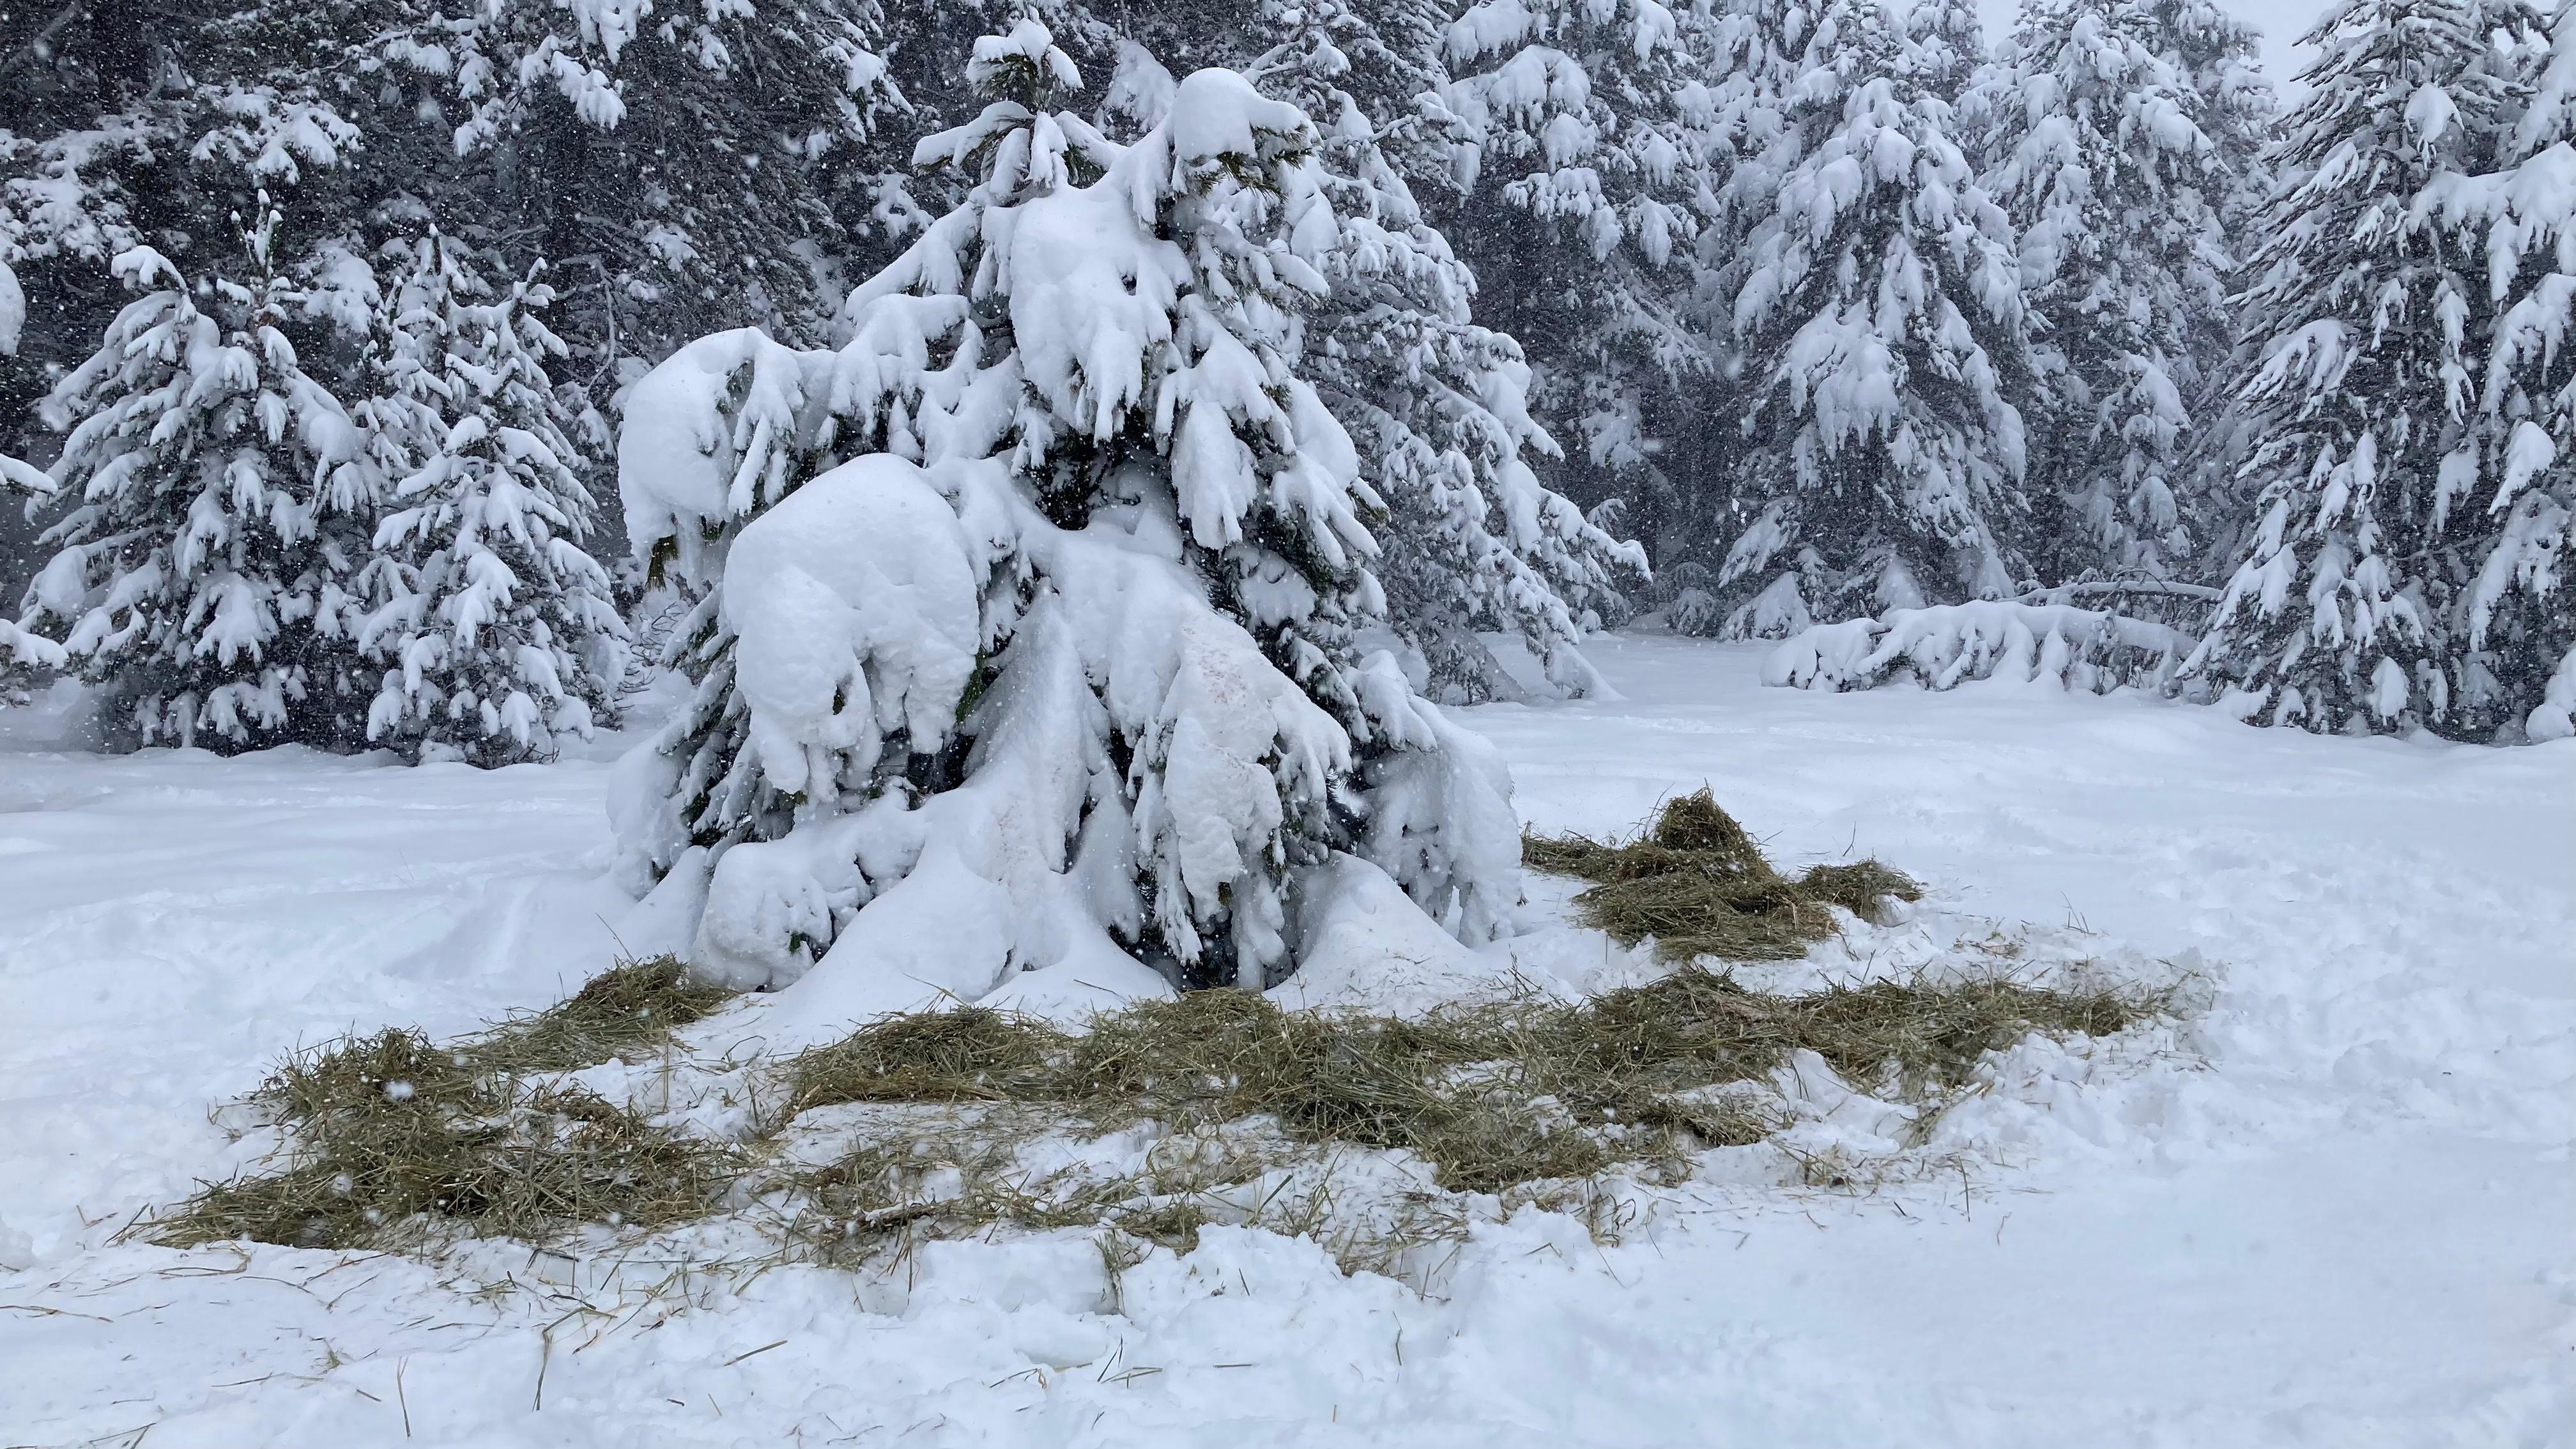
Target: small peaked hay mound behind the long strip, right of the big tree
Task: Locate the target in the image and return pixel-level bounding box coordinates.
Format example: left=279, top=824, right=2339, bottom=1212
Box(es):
left=1520, top=789, right=1922, bottom=962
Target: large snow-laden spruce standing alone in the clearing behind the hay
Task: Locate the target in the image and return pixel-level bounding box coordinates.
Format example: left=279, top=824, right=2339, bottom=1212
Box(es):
left=618, top=20, right=1517, bottom=990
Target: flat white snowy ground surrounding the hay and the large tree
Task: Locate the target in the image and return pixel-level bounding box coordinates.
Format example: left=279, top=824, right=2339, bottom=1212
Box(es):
left=0, top=637, right=2576, bottom=1449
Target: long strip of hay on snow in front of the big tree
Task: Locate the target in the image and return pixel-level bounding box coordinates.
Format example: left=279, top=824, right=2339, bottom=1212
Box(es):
left=788, top=967, right=2161, bottom=1191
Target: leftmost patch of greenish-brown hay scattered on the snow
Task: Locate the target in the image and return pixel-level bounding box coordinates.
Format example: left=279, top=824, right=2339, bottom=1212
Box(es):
left=142, top=962, right=744, bottom=1248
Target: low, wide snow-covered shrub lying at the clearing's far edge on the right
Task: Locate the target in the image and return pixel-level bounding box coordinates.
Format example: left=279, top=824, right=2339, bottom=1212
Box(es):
left=1762, top=601, right=2195, bottom=694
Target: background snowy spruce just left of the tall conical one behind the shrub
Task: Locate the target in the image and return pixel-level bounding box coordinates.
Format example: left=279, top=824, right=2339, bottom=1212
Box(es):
left=1425, top=0, right=1726, bottom=560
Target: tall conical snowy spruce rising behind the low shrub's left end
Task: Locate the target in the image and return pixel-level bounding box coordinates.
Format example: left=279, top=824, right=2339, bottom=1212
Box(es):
left=1687, top=0, right=2027, bottom=637
